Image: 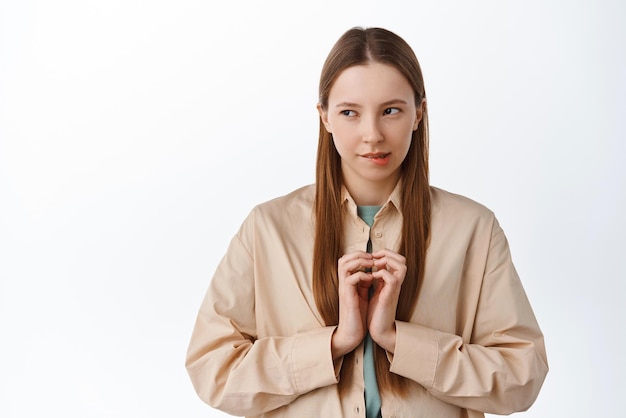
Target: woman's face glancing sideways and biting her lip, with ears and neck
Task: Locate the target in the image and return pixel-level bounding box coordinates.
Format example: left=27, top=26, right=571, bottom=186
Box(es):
left=318, top=63, right=424, bottom=204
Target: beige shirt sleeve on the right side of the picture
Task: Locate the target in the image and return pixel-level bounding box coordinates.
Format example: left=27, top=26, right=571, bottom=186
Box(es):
left=389, top=220, right=548, bottom=414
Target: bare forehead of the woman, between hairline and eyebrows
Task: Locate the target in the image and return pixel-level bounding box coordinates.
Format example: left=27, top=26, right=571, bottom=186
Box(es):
left=328, top=63, right=414, bottom=103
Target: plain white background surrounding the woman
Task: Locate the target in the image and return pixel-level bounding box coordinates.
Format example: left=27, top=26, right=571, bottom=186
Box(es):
left=0, top=0, right=626, bottom=418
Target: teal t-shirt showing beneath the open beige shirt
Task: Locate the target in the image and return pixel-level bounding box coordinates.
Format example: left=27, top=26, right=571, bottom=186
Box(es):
left=357, top=206, right=381, bottom=418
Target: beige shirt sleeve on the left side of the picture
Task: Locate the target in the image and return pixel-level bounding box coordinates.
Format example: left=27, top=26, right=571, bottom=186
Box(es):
left=186, top=217, right=338, bottom=415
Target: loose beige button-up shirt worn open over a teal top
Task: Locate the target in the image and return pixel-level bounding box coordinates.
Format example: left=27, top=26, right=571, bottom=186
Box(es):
left=186, top=186, right=548, bottom=418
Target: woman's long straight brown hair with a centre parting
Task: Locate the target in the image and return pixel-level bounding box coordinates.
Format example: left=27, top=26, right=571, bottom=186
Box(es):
left=313, top=28, right=430, bottom=395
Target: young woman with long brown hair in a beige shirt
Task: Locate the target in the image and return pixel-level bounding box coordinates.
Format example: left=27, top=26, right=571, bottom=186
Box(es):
left=186, top=28, right=548, bottom=418
